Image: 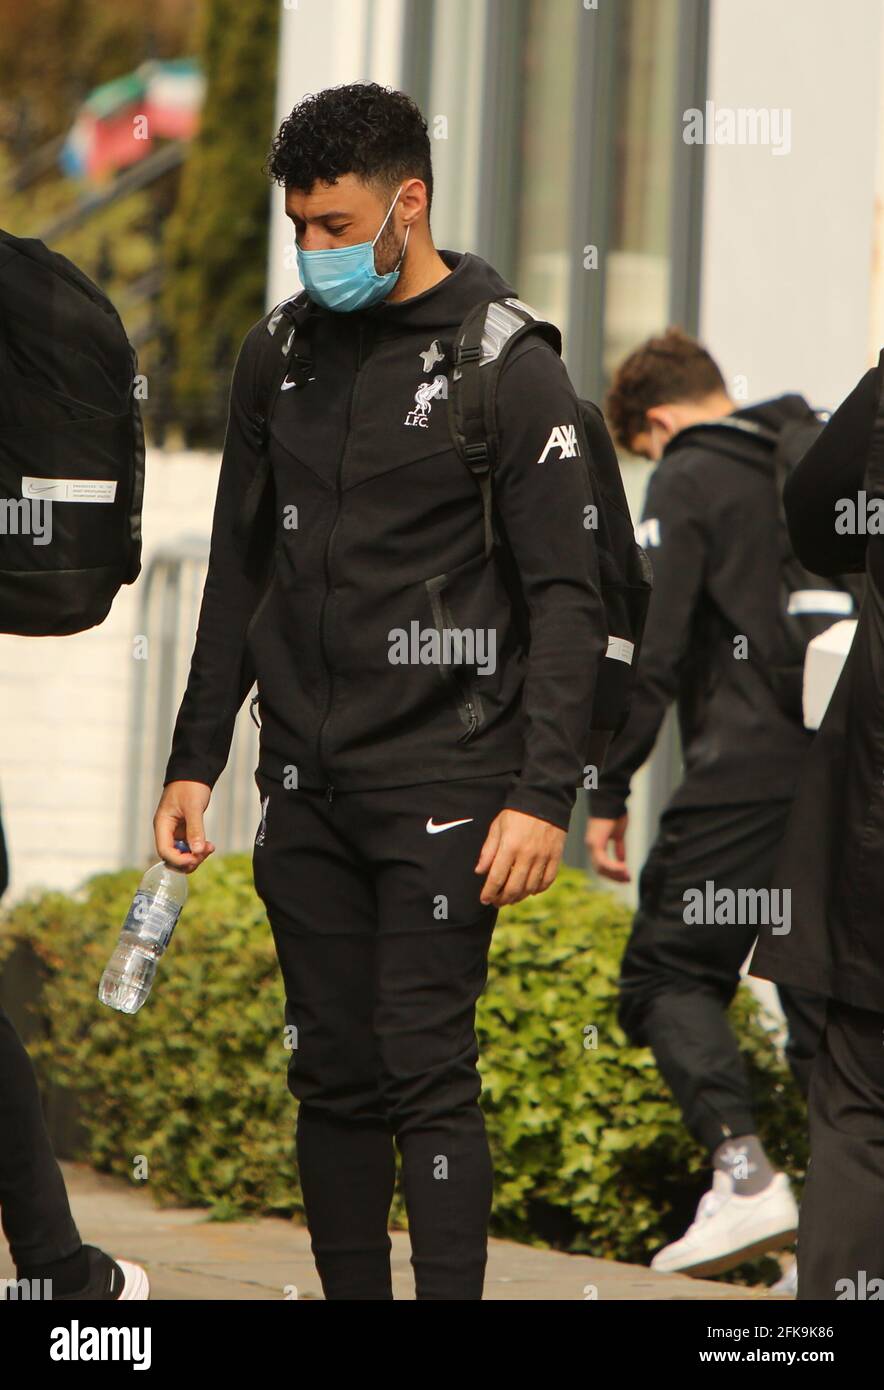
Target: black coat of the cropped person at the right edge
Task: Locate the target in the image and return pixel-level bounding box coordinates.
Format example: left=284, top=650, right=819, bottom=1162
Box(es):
left=751, top=352, right=884, bottom=1013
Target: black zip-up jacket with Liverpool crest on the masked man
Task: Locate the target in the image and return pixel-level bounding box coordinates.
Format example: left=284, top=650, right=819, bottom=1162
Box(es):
left=164, top=252, right=607, bottom=828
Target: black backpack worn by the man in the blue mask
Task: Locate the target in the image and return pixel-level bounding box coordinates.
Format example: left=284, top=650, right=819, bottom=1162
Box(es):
left=238, top=292, right=652, bottom=769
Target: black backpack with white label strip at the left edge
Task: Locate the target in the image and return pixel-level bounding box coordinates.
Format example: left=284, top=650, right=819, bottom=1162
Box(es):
left=0, top=229, right=145, bottom=637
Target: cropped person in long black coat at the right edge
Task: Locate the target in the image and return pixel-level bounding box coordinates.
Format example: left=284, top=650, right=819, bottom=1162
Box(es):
left=751, top=352, right=884, bottom=1302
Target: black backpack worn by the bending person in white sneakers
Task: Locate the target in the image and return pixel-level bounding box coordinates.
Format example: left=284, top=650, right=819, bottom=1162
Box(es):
left=678, top=407, right=862, bottom=726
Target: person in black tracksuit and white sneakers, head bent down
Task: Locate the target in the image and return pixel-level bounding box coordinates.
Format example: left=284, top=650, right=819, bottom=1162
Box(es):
left=587, top=329, right=823, bottom=1273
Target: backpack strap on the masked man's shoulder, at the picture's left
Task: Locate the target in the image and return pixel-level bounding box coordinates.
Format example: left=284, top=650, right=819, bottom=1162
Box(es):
left=234, top=291, right=313, bottom=546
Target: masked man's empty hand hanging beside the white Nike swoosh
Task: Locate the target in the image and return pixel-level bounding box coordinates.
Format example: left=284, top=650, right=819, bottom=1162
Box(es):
left=475, top=810, right=566, bottom=908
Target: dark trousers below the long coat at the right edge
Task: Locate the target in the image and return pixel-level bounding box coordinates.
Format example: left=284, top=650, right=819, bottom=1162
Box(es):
left=798, top=999, right=884, bottom=1302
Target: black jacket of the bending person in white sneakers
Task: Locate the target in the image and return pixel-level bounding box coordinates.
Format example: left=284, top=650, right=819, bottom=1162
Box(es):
left=589, top=395, right=812, bottom=819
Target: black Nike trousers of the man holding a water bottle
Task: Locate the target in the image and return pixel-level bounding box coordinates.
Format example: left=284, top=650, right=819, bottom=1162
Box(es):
left=253, top=773, right=513, bottom=1300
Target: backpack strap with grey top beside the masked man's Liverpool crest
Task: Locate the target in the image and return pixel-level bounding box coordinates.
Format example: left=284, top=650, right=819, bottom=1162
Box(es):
left=448, top=296, right=562, bottom=556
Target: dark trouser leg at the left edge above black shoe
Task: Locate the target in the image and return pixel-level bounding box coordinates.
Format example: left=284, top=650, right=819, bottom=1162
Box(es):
left=0, top=1009, right=81, bottom=1273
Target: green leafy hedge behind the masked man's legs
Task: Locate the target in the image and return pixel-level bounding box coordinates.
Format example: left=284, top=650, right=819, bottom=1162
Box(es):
left=0, top=855, right=806, bottom=1262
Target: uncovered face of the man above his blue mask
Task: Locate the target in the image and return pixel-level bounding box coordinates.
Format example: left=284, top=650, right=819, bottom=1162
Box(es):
left=285, top=174, right=403, bottom=275
